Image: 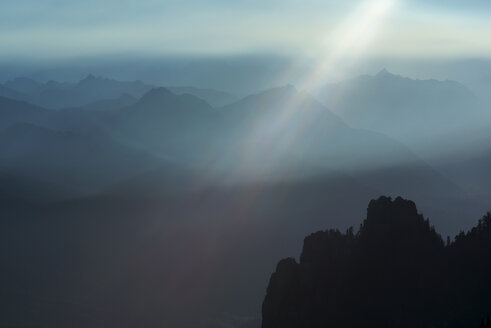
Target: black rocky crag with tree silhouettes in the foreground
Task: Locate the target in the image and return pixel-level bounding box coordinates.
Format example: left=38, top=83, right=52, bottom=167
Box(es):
left=262, top=197, right=491, bottom=328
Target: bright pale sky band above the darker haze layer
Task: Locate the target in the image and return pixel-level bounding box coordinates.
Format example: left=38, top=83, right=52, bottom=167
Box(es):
left=0, top=0, right=491, bottom=60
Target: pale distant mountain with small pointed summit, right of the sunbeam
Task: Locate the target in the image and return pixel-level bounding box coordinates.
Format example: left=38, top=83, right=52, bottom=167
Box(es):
left=316, top=69, right=484, bottom=145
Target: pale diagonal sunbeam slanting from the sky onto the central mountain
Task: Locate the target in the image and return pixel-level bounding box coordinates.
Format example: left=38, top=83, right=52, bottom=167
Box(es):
left=229, top=0, right=397, bottom=184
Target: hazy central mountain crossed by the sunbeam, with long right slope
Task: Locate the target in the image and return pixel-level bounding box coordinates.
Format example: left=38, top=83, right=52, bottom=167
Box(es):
left=216, top=86, right=463, bottom=205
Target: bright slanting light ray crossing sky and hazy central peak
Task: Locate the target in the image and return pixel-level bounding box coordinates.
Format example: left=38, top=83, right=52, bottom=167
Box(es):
left=234, top=0, right=397, bottom=177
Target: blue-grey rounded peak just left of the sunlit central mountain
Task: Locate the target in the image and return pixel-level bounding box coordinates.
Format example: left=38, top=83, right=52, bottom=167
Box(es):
left=108, top=87, right=215, bottom=160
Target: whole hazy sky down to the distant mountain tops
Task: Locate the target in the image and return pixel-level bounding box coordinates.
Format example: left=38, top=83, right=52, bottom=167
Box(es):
left=0, top=0, right=491, bottom=94
